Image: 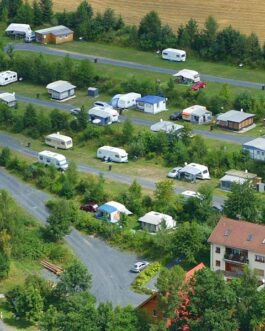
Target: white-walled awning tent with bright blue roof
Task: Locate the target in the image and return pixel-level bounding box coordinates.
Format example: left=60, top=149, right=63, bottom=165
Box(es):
left=136, top=95, right=167, bottom=114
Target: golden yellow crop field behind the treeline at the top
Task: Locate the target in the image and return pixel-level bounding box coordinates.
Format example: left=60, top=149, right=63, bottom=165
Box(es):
left=54, top=0, right=265, bottom=42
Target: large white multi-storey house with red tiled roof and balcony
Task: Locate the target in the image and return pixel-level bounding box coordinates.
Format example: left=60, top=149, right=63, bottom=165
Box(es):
left=208, top=217, right=265, bottom=281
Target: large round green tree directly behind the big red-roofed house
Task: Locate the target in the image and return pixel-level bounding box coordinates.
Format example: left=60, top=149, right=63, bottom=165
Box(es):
left=224, top=181, right=261, bottom=222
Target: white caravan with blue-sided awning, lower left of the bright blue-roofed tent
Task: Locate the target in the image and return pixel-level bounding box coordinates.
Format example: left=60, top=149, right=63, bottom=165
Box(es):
left=88, top=106, right=119, bottom=125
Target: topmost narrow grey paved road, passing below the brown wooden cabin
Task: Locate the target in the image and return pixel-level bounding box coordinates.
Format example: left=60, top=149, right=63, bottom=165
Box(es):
left=8, top=43, right=263, bottom=89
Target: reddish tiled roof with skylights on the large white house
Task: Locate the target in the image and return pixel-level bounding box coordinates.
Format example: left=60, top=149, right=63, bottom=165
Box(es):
left=208, top=217, right=265, bottom=254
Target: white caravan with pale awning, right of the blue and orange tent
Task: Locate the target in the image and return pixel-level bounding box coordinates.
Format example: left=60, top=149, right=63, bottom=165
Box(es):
left=138, top=211, right=176, bottom=232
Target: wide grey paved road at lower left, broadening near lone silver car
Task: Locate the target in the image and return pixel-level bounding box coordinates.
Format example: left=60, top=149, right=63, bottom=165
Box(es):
left=0, top=168, right=147, bottom=306
